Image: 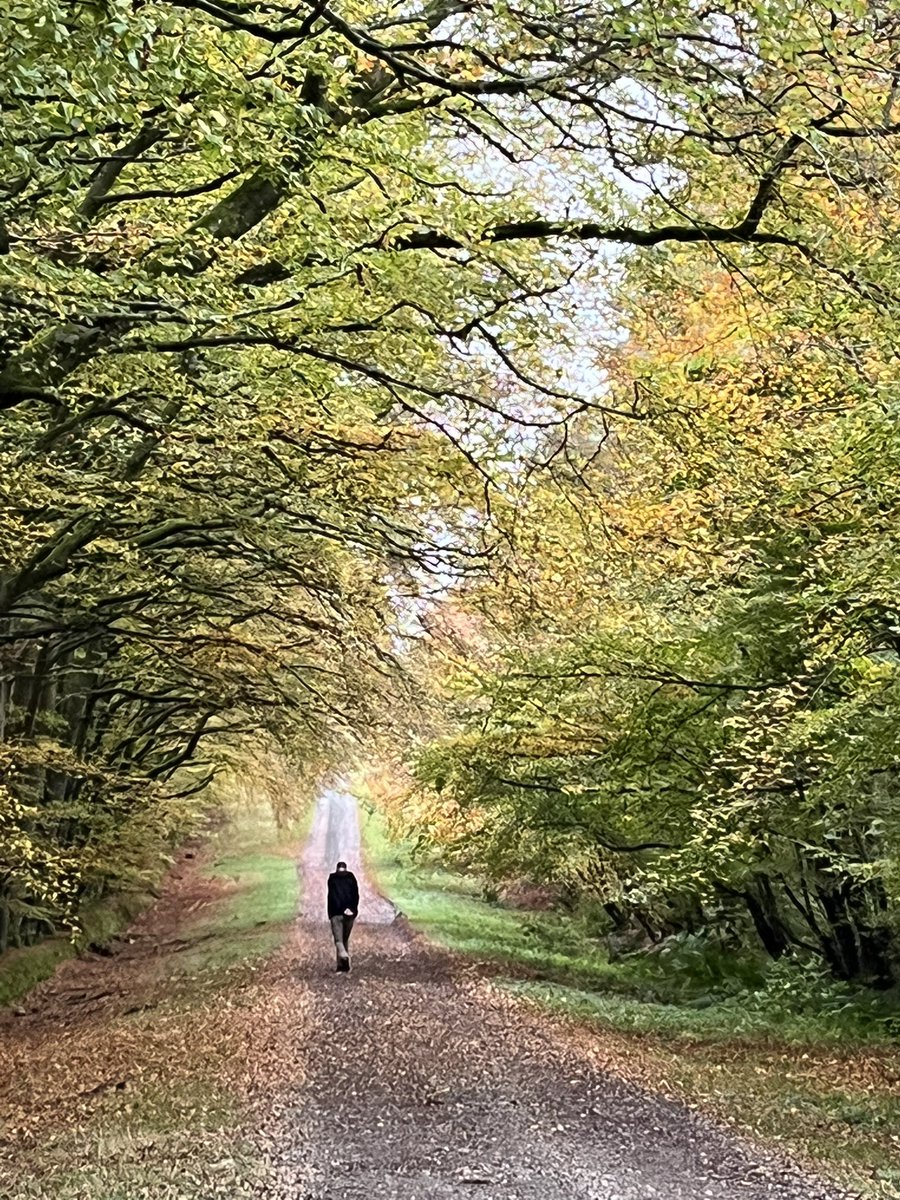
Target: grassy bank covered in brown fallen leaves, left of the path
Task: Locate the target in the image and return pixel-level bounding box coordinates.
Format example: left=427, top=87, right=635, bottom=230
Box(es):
left=0, top=808, right=304, bottom=1200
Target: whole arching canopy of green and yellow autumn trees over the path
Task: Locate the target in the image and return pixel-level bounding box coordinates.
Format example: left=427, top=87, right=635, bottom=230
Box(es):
left=0, top=0, right=900, bottom=985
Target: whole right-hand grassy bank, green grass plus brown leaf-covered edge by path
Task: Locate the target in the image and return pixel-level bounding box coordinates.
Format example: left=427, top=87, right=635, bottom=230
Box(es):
left=364, top=814, right=900, bottom=1200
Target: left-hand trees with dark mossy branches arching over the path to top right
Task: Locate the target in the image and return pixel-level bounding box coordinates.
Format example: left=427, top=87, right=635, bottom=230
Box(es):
left=0, top=0, right=898, bottom=955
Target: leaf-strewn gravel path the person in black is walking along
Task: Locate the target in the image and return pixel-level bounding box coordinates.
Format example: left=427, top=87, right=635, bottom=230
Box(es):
left=253, top=794, right=845, bottom=1200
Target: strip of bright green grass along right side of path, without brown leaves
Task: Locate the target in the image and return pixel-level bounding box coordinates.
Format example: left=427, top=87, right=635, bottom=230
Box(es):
left=362, top=812, right=896, bottom=1045
